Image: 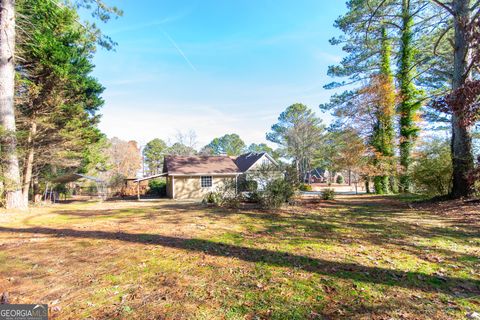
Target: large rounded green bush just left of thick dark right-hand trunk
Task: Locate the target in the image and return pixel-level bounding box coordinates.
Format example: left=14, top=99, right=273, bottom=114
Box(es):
left=412, top=139, right=452, bottom=196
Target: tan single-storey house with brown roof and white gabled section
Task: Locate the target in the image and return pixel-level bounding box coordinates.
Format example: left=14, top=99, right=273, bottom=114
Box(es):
left=136, top=153, right=278, bottom=199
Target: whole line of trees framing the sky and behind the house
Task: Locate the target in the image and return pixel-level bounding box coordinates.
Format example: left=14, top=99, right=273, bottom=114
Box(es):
left=0, top=0, right=480, bottom=208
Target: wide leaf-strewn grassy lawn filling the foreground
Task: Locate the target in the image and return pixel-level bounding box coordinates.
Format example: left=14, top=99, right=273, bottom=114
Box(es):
left=0, top=196, right=480, bottom=319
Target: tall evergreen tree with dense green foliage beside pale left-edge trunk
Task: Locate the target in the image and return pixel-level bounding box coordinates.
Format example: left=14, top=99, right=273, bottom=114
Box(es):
left=12, top=0, right=117, bottom=202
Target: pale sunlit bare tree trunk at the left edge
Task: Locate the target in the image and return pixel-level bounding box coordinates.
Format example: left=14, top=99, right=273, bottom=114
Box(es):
left=0, top=0, right=27, bottom=209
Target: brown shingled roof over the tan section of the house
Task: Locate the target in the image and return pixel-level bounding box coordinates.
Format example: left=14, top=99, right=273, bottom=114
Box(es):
left=163, top=156, right=240, bottom=175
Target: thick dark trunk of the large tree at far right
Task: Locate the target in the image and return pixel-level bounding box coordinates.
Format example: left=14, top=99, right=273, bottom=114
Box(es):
left=451, top=0, right=474, bottom=198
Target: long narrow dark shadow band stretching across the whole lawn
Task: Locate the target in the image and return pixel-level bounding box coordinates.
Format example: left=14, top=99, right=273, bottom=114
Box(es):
left=0, top=227, right=480, bottom=296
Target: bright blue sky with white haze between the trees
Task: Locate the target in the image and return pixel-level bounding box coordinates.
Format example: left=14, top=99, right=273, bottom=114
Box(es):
left=89, top=0, right=346, bottom=147
